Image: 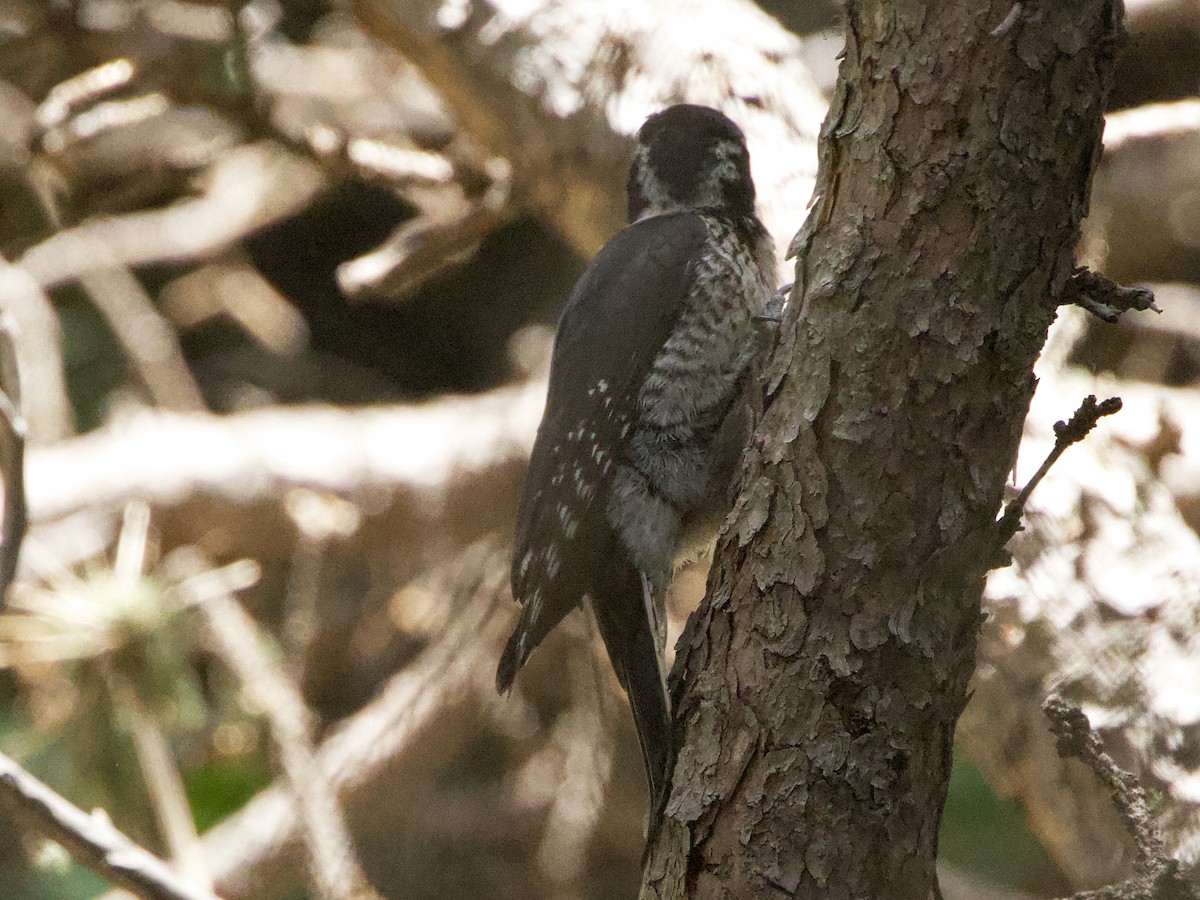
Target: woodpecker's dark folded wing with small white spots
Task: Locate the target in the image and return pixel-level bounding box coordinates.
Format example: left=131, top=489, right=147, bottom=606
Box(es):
left=497, top=212, right=707, bottom=691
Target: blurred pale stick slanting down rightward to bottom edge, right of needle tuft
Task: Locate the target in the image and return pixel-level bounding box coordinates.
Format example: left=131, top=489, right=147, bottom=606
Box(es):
left=187, top=578, right=378, bottom=900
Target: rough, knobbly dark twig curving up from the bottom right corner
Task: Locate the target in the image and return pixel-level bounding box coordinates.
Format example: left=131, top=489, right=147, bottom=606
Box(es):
left=1042, top=696, right=1198, bottom=900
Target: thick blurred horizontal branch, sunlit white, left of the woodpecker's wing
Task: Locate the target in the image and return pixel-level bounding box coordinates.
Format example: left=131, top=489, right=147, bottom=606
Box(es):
left=26, top=383, right=546, bottom=522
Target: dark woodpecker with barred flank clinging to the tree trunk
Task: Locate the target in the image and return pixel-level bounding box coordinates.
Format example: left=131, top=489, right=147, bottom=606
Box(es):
left=496, top=104, right=775, bottom=822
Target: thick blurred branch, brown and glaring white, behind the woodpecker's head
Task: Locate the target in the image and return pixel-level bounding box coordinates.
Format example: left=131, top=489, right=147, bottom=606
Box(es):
left=354, top=0, right=826, bottom=267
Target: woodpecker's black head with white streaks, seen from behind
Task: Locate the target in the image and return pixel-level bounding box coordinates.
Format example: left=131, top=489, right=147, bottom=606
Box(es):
left=629, top=103, right=755, bottom=222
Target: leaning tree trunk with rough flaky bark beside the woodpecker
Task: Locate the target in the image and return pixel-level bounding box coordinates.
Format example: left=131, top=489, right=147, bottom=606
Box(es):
left=643, top=0, right=1121, bottom=900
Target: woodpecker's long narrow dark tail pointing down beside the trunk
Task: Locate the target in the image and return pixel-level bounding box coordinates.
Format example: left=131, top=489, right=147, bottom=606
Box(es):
left=592, top=554, right=674, bottom=838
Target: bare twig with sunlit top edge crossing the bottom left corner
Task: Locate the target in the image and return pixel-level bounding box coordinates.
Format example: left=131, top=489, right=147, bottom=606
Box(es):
left=0, top=754, right=218, bottom=900
